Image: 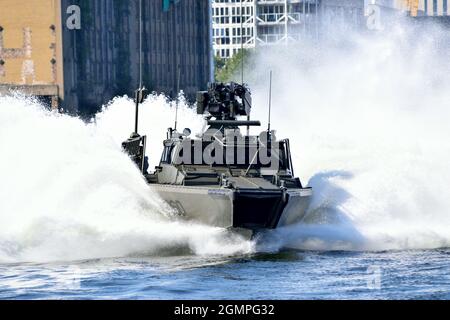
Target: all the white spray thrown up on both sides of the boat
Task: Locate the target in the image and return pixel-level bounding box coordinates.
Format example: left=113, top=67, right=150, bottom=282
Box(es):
left=0, top=20, right=450, bottom=262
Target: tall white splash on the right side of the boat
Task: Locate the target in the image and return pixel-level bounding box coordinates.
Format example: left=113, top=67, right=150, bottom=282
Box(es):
left=253, top=20, right=450, bottom=250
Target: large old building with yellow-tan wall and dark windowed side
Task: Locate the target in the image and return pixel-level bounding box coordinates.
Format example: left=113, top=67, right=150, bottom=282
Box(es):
left=0, top=0, right=213, bottom=114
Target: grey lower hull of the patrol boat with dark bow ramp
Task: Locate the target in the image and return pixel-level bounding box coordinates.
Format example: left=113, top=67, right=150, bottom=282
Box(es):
left=151, top=185, right=312, bottom=233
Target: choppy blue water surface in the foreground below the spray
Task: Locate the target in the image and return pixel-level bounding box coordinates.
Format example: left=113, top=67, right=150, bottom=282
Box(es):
left=0, top=249, right=450, bottom=300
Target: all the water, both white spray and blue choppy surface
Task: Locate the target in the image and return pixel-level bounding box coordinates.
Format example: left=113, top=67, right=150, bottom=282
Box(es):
left=0, top=22, right=450, bottom=299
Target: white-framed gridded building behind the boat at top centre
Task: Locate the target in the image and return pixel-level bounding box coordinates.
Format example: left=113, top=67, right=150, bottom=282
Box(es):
left=212, top=0, right=320, bottom=58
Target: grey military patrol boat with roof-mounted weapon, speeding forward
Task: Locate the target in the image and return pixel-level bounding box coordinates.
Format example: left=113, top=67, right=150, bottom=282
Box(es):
left=122, top=83, right=312, bottom=237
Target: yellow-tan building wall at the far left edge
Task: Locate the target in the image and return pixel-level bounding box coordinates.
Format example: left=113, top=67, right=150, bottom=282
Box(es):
left=0, top=0, right=64, bottom=107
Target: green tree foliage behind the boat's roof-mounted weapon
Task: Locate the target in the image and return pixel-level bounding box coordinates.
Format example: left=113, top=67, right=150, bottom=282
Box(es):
left=214, top=50, right=254, bottom=82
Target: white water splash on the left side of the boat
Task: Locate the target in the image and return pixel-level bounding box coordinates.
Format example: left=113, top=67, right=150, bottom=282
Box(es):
left=0, top=96, right=253, bottom=262
